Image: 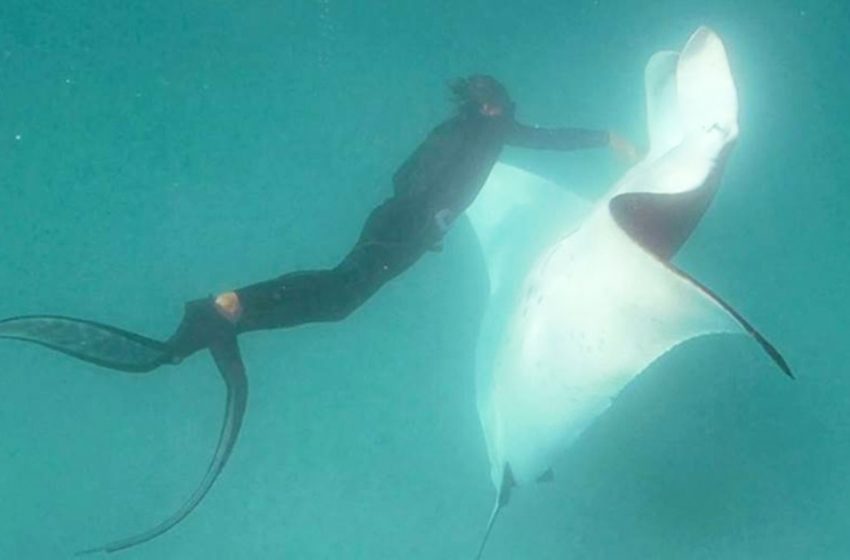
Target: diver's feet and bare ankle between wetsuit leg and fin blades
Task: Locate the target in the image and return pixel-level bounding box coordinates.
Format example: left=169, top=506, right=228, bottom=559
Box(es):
left=168, top=294, right=242, bottom=364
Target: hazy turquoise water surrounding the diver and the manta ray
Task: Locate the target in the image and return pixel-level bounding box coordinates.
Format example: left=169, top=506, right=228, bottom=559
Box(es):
left=0, top=0, right=850, bottom=560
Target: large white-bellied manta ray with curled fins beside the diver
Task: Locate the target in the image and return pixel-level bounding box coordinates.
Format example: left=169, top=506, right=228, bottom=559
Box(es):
left=468, top=27, right=793, bottom=558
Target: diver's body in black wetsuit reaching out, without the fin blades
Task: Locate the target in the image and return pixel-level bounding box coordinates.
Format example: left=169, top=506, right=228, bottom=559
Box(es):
left=169, top=75, right=635, bottom=361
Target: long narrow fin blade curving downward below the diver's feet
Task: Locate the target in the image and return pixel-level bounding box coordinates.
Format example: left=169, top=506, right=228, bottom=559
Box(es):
left=77, top=336, right=248, bottom=555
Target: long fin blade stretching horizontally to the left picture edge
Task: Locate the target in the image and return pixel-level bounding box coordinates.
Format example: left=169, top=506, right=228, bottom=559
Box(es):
left=0, top=315, right=171, bottom=373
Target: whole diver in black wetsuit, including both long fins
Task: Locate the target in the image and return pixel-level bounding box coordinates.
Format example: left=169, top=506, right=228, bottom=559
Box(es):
left=0, top=75, right=637, bottom=552
